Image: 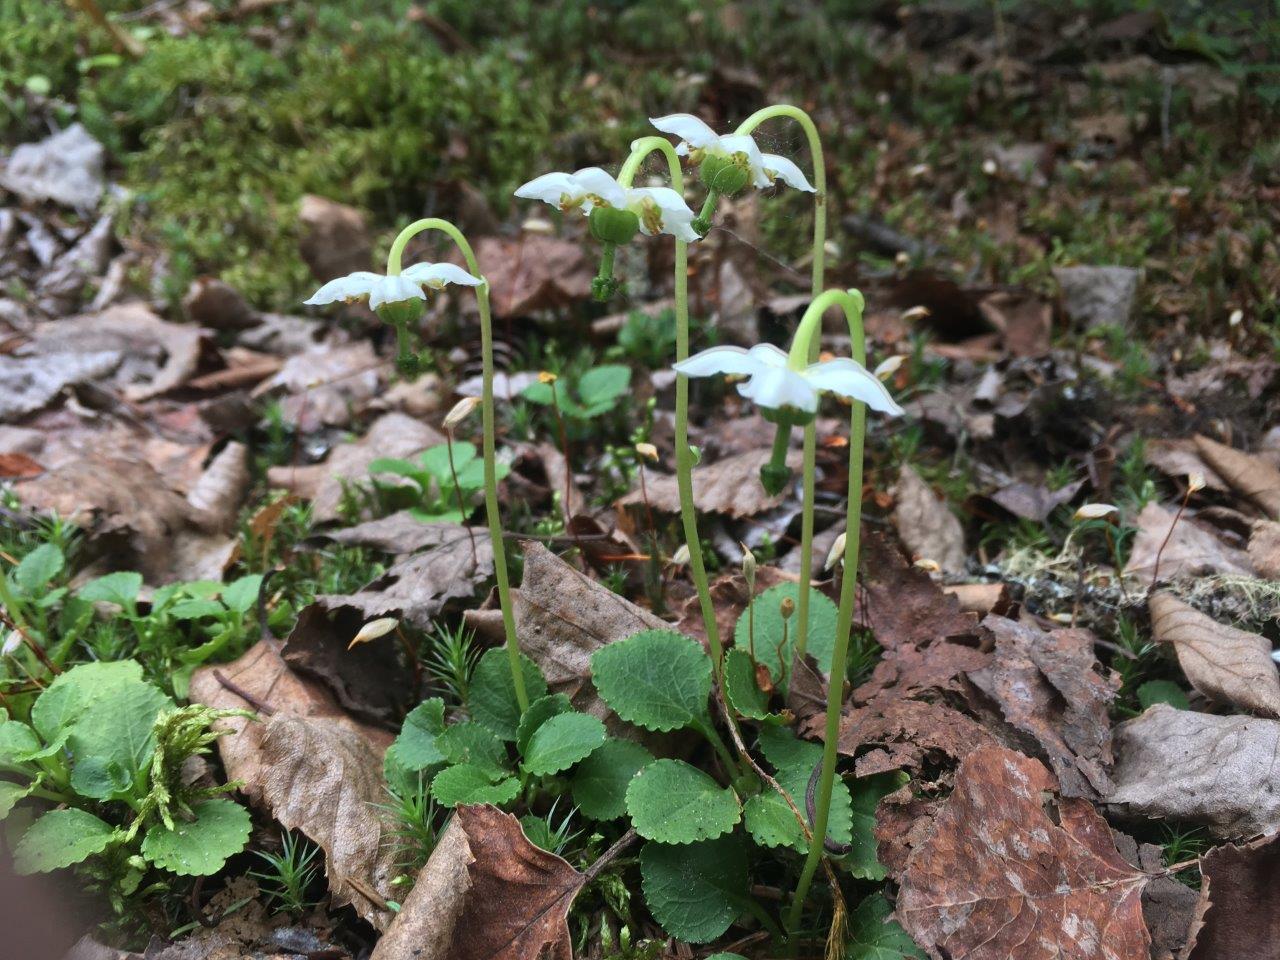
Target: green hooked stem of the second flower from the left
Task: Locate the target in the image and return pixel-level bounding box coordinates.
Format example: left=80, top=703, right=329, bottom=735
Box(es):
left=618, top=137, right=724, bottom=682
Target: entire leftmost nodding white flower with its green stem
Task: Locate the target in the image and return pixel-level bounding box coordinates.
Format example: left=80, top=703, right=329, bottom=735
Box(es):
left=307, top=218, right=529, bottom=712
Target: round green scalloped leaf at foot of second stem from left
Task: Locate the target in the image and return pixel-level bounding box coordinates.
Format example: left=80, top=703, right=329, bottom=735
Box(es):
left=591, top=630, right=712, bottom=732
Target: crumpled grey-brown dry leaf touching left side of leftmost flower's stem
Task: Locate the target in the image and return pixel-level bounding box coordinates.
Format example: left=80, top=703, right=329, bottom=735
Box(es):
left=316, top=524, right=493, bottom=630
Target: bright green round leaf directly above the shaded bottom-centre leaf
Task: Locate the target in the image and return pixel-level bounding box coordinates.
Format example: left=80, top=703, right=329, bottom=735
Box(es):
left=627, top=760, right=742, bottom=844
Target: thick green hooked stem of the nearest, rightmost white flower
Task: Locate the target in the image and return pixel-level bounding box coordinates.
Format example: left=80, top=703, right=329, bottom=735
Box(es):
left=787, top=291, right=867, bottom=931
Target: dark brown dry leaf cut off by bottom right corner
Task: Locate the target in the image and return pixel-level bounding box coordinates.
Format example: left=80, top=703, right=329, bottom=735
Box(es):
left=1189, top=836, right=1280, bottom=960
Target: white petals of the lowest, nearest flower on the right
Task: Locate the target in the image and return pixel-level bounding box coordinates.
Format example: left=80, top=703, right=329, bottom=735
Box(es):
left=676, top=343, right=902, bottom=416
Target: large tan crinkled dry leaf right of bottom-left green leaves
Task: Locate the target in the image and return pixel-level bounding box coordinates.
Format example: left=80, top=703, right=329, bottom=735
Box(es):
left=189, top=640, right=396, bottom=929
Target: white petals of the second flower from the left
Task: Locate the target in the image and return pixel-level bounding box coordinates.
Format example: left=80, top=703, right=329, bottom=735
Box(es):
left=516, top=166, right=700, bottom=242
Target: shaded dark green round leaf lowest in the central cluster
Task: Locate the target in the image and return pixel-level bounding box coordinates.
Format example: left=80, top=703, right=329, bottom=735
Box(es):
left=640, top=835, right=746, bottom=943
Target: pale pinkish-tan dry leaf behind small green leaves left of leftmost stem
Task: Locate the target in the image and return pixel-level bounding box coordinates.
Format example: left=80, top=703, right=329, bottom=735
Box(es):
left=266, top=413, right=444, bottom=524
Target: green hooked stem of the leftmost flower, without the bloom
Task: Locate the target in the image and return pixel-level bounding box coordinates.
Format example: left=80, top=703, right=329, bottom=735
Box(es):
left=387, top=218, right=529, bottom=713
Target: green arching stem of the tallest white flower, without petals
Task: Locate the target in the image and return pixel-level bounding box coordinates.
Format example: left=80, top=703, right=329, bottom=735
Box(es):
left=737, top=104, right=827, bottom=659
